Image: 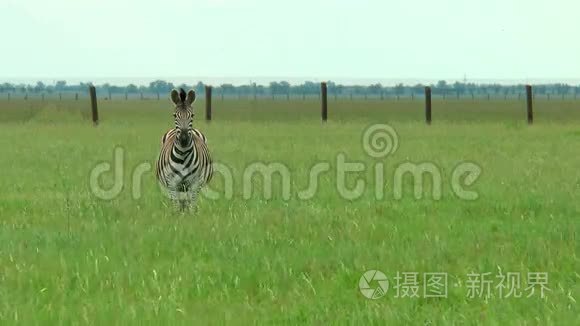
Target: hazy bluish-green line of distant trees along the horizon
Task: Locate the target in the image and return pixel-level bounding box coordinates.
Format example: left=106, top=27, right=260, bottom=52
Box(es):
left=0, top=80, right=580, bottom=97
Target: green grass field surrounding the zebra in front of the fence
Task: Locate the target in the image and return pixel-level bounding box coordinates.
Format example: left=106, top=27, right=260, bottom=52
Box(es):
left=0, top=100, right=580, bottom=325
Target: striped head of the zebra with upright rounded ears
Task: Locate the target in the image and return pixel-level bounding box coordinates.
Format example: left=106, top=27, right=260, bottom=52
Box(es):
left=171, top=88, right=195, bottom=147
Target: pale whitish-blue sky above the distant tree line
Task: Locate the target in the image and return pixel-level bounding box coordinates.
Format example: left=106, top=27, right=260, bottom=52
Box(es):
left=0, top=0, right=580, bottom=82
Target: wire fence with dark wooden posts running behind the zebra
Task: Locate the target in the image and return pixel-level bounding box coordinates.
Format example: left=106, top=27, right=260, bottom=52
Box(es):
left=0, top=83, right=580, bottom=125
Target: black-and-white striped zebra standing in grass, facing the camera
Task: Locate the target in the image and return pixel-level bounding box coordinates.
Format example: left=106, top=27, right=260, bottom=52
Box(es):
left=156, top=88, right=213, bottom=211
